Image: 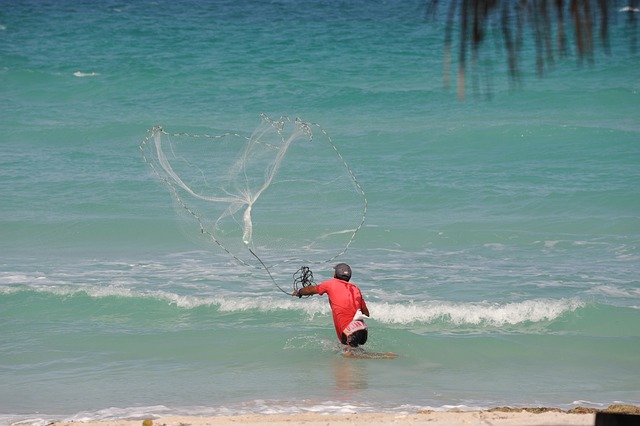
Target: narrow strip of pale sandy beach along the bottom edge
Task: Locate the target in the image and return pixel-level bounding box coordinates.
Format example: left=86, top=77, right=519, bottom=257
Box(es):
left=45, top=405, right=640, bottom=426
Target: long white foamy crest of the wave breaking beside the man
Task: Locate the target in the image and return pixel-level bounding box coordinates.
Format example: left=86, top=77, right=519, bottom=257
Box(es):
left=2, top=276, right=584, bottom=327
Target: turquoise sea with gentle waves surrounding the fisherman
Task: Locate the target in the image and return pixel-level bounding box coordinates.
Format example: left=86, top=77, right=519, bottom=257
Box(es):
left=0, top=0, right=640, bottom=424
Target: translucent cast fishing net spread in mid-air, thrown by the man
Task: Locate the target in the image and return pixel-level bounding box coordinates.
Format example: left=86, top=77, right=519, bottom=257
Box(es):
left=140, top=115, right=367, bottom=292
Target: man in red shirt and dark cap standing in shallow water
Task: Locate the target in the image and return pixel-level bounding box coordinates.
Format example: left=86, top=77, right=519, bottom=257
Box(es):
left=292, top=263, right=369, bottom=348
